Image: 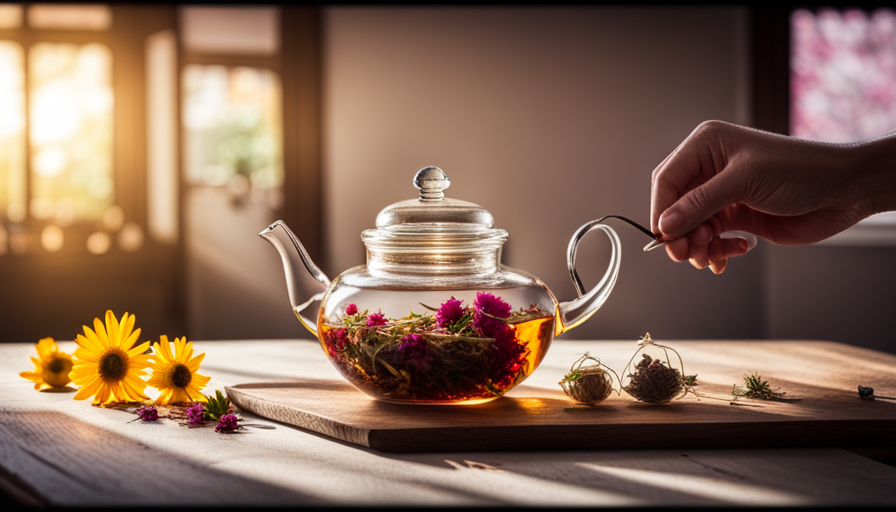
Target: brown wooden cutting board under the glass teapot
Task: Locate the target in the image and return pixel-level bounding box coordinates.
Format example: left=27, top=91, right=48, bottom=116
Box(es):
left=226, top=341, right=896, bottom=453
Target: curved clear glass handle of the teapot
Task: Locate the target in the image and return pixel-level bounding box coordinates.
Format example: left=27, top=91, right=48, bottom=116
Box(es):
left=556, top=219, right=622, bottom=334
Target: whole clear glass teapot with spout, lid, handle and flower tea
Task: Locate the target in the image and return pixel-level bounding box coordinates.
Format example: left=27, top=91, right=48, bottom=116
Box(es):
left=259, top=167, right=621, bottom=404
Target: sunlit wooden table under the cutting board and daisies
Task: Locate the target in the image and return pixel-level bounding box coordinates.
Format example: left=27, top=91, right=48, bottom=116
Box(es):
left=0, top=340, right=896, bottom=506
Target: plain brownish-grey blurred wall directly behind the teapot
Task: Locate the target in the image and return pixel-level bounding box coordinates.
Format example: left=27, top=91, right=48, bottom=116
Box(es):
left=322, top=7, right=766, bottom=339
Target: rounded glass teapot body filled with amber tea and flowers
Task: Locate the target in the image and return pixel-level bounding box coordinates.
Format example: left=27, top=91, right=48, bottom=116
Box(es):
left=317, top=266, right=557, bottom=404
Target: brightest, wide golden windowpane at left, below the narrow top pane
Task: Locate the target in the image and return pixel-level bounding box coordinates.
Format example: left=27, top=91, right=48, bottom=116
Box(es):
left=28, top=43, right=114, bottom=224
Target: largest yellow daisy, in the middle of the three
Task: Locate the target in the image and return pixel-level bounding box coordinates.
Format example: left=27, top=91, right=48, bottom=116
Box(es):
left=71, top=311, right=150, bottom=404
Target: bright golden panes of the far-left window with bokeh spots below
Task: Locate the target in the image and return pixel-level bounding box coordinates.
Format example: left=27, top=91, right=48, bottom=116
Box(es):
left=0, top=4, right=143, bottom=255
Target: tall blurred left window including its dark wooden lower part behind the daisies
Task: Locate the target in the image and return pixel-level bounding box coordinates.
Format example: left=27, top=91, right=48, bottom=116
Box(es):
left=0, top=4, right=184, bottom=342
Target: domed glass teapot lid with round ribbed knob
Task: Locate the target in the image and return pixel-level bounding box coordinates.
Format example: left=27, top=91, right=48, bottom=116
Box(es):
left=376, top=167, right=495, bottom=231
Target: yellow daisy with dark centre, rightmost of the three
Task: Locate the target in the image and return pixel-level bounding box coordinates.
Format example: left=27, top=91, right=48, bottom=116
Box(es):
left=147, top=334, right=210, bottom=405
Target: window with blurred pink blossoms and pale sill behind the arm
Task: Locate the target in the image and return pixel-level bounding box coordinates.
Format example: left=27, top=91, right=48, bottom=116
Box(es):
left=790, top=8, right=896, bottom=245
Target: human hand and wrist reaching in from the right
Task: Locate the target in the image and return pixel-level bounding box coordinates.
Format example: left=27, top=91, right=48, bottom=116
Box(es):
left=650, top=121, right=880, bottom=274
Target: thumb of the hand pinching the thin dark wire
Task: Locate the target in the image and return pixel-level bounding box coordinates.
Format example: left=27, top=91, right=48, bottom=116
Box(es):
left=659, top=167, right=746, bottom=238
